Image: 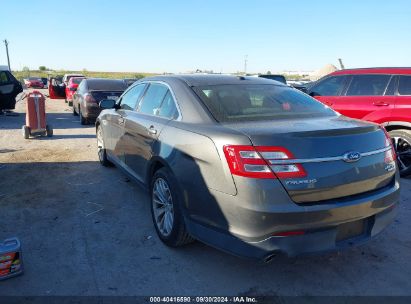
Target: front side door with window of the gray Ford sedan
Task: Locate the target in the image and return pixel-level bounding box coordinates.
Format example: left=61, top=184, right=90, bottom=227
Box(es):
left=109, top=83, right=147, bottom=164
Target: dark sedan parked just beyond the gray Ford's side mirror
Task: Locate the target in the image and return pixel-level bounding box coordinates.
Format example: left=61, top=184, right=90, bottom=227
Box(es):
left=73, top=78, right=127, bottom=125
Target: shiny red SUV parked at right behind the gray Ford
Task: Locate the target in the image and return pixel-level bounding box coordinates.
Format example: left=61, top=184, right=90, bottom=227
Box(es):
left=307, top=68, right=411, bottom=176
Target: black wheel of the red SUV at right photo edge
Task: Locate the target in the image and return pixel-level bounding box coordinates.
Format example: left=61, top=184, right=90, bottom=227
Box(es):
left=388, top=129, right=411, bottom=177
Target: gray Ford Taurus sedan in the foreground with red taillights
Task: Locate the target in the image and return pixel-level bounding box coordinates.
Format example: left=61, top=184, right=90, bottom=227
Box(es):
left=96, top=75, right=400, bottom=260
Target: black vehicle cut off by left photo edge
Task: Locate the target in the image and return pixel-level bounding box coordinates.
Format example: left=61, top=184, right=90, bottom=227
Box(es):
left=0, top=66, right=23, bottom=113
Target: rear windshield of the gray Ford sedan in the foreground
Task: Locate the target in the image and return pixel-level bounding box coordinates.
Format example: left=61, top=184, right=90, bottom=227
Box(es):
left=194, top=85, right=337, bottom=122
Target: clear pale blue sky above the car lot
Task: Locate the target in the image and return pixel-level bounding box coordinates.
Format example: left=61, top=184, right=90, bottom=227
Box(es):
left=0, top=0, right=411, bottom=73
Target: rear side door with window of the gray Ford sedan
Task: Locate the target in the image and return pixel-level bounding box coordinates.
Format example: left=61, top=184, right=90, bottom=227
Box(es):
left=125, top=82, right=178, bottom=183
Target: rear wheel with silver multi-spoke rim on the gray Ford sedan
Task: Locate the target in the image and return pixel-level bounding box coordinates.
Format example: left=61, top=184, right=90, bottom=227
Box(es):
left=150, top=168, right=194, bottom=247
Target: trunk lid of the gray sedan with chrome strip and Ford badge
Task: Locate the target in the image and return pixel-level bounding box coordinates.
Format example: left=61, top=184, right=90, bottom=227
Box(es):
left=224, top=116, right=395, bottom=204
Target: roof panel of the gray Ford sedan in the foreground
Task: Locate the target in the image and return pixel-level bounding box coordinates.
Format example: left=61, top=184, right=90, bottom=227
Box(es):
left=144, top=74, right=284, bottom=87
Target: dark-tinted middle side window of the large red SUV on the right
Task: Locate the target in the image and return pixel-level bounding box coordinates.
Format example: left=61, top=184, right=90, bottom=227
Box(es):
left=347, top=75, right=391, bottom=96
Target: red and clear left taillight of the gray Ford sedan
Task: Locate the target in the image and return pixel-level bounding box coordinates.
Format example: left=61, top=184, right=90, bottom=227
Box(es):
left=224, top=146, right=306, bottom=178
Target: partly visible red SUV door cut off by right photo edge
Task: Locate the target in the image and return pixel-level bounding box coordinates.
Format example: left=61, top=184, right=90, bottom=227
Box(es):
left=391, top=75, right=411, bottom=124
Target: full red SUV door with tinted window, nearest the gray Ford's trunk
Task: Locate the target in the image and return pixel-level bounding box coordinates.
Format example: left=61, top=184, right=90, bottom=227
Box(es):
left=331, top=74, right=395, bottom=123
